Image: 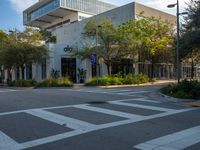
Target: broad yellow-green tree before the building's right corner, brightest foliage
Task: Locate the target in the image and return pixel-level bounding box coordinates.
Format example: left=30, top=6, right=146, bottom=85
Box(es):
left=119, top=16, right=173, bottom=78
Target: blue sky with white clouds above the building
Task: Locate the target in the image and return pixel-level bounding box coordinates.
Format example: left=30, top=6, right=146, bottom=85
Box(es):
left=0, top=0, right=189, bottom=32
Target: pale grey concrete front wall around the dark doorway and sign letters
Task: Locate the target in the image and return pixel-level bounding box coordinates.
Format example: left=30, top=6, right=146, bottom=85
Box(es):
left=44, top=4, right=134, bottom=80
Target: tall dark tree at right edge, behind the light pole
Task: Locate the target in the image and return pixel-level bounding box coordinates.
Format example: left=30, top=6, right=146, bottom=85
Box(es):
left=180, top=0, right=200, bottom=79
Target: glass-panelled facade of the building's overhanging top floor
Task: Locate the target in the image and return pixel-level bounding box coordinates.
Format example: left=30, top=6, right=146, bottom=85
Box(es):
left=23, top=0, right=116, bottom=24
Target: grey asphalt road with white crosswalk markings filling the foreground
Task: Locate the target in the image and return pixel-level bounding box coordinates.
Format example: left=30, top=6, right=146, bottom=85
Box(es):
left=0, top=86, right=200, bottom=150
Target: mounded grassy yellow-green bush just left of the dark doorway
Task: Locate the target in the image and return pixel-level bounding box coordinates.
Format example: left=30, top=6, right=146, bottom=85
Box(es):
left=36, top=77, right=73, bottom=87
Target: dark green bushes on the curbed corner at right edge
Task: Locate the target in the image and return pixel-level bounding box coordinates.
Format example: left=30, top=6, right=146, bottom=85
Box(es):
left=161, top=80, right=200, bottom=99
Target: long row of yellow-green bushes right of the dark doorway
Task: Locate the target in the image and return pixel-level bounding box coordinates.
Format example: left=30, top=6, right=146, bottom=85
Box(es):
left=86, top=74, right=149, bottom=86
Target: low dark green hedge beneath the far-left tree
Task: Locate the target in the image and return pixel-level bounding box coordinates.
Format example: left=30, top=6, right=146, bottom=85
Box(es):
left=8, top=80, right=37, bottom=87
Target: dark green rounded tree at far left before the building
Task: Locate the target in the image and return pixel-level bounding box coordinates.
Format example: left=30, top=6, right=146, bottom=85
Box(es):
left=0, top=28, right=48, bottom=80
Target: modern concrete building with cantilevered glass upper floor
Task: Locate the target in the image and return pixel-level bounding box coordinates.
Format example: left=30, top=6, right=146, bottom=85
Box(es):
left=19, top=0, right=176, bottom=82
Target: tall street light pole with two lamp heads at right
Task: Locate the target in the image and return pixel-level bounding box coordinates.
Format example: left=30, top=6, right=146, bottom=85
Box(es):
left=167, top=0, right=187, bottom=83
